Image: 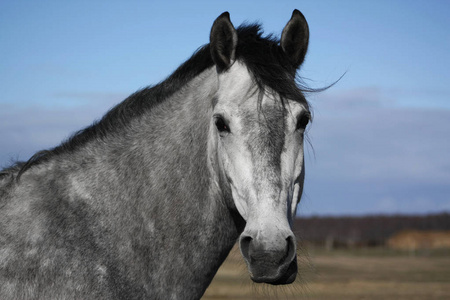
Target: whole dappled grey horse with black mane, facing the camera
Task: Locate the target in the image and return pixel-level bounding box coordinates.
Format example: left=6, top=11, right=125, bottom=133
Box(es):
left=0, top=10, right=311, bottom=299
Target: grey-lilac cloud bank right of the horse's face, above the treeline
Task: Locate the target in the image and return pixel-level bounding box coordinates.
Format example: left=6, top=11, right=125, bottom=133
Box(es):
left=305, top=88, right=450, bottom=214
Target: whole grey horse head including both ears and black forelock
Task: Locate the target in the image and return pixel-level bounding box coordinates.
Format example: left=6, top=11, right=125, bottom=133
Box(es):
left=210, top=10, right=310, bottom=284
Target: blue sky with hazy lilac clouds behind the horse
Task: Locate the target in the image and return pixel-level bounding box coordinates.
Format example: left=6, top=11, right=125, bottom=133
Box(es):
left=0, top=0, right=450, bottom=215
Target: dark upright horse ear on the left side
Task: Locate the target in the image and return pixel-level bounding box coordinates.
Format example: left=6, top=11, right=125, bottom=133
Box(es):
left=209, top=12, right=238, bottom=72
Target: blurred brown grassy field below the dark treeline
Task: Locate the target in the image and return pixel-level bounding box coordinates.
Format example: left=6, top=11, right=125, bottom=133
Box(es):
left=202, top=248, right=450, bottom=300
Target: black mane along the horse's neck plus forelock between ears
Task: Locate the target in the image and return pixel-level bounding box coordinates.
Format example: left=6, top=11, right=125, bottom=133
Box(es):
left=11, top=24, right=312, bottom=180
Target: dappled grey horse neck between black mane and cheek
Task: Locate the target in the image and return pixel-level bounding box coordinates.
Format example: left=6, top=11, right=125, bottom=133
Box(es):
left=8, top=68, right=240, bottom=299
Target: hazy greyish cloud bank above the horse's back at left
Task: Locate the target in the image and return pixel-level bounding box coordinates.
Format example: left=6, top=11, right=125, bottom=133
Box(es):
left=0, top=93, right=125, bottom=167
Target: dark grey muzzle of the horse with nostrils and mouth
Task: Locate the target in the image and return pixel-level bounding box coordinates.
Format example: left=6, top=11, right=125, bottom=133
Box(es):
left=239, top=232, right=297, bottom=284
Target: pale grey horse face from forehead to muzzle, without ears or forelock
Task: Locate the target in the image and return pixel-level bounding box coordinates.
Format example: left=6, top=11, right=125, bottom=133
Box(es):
left=212, top=61, right=309, bottom=284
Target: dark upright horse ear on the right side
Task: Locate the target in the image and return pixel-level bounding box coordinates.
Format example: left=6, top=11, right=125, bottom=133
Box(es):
left=280, top=9, right=309, bottom=69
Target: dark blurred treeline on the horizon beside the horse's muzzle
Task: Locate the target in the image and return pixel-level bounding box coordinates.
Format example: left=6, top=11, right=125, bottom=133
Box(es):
left=294, top=213, right=450, bottom=247
